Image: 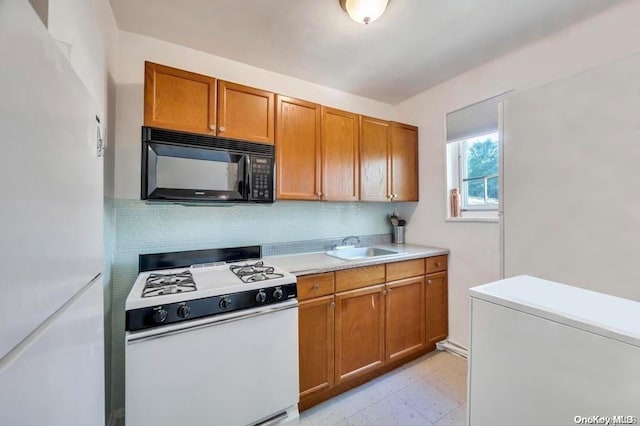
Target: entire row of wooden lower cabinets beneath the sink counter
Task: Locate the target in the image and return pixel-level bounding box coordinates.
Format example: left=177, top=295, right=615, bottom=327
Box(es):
left=298, top=255, right=448, bottom=411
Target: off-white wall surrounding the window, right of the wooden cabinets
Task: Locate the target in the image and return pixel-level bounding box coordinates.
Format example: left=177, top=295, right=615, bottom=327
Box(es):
left=396, top=1, right=640, bottom=347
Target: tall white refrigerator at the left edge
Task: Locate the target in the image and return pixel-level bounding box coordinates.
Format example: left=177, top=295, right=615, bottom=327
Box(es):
left=0, top=0, right=105, bottom=426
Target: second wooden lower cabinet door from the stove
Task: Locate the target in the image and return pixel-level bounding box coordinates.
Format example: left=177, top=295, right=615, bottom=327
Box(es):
left=335, top=285, right=385, bottom=384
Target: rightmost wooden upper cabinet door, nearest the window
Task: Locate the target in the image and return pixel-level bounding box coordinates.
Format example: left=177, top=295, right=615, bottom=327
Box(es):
left=391, top=123, right=418, bottom=201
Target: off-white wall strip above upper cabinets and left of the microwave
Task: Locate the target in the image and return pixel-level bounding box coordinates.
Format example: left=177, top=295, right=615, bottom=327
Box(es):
left=116, top=31, right=393, bottom=199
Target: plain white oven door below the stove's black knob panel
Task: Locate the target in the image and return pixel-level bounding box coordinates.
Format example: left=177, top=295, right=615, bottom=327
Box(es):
left=126, top=300, right=298, bottom=426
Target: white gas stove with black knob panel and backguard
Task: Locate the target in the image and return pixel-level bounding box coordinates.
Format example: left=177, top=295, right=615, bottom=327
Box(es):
left=125, top=246, right=298, bottom=426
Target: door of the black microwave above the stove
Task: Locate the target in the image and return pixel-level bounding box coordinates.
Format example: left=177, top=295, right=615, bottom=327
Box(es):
left=141, top=142, right=249, bottom=202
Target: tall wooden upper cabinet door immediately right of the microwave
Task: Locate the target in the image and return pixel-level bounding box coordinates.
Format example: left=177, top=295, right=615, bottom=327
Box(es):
left=276, top=95, right=322, bottom=200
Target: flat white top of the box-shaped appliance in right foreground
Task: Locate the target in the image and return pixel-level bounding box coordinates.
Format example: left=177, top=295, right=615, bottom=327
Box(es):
left=469, top=275, right=640, bottom=346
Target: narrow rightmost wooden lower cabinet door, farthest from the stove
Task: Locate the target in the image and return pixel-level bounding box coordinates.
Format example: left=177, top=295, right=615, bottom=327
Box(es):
left=426, top=272, right=449, bottom=347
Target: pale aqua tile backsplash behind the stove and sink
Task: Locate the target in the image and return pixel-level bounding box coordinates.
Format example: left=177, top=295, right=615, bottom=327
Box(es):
left=111, top=199, right=395, bottom=410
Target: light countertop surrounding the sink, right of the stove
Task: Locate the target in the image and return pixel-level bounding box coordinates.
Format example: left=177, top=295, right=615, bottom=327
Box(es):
left=265, top=244, right=449, bottom=276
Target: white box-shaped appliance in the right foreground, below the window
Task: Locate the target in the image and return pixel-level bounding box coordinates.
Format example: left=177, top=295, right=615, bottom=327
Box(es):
left=468, top=276, right=640, bottom=426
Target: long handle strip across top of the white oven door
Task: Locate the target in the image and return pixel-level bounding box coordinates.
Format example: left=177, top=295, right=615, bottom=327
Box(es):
left=126, top=300, right=298, bottom=344
